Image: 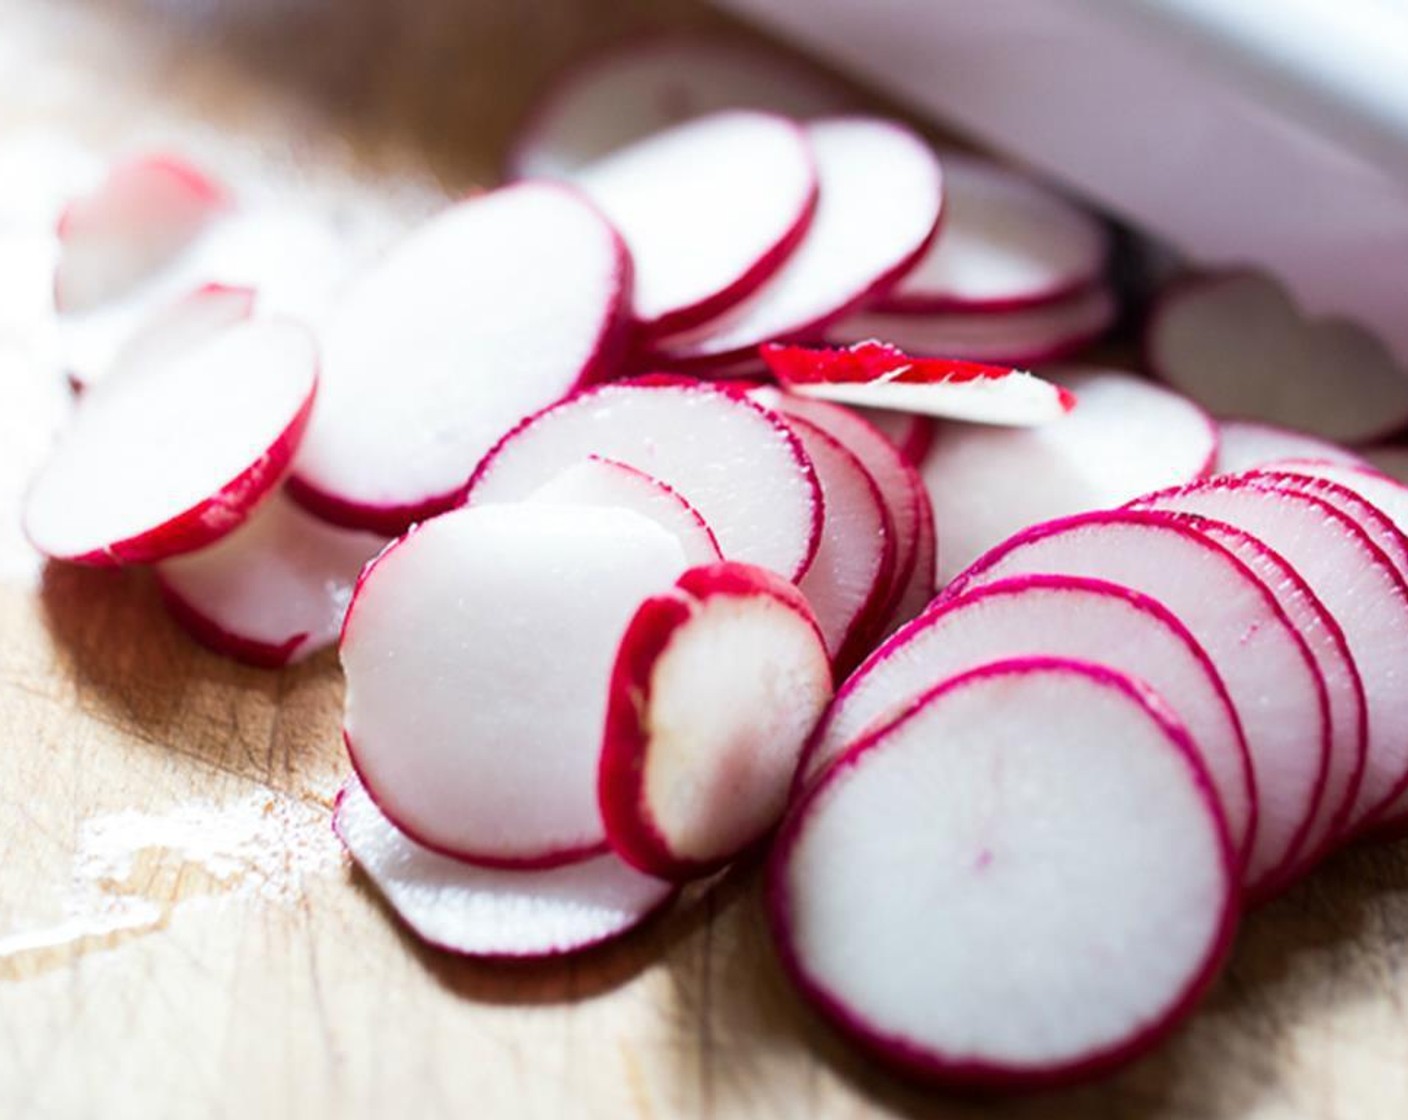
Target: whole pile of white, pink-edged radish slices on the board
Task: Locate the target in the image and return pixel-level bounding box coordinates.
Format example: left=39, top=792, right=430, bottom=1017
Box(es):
left=24, top=32, right=1408, bottom=1085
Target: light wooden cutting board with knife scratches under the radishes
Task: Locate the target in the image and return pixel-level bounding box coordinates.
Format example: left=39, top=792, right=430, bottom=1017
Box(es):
left=8, top=0, right=1408, bottom=1120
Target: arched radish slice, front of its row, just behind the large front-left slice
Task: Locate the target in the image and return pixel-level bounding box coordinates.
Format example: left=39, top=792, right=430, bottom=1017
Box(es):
left=466, top=378, right=824, bottom=580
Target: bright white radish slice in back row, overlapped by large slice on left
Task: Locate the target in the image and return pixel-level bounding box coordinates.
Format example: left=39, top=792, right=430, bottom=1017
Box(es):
left=573, top=111, right=817, bottom=332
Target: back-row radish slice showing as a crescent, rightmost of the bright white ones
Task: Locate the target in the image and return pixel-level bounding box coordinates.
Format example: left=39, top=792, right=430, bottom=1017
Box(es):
left=655, top=117, right=943, bottom=368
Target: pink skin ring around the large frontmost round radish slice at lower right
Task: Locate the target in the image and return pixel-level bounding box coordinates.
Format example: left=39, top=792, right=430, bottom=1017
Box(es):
left=766, top=658, right=1239, bottom=1090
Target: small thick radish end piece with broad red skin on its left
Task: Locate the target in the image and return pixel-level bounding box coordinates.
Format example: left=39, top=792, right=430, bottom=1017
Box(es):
left=598, top=564, right=831, bottom=879
